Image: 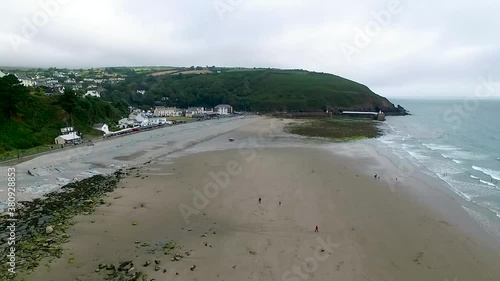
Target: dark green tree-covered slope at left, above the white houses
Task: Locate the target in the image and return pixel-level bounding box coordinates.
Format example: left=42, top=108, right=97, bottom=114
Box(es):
left=0, top=75, right=128, bottom=154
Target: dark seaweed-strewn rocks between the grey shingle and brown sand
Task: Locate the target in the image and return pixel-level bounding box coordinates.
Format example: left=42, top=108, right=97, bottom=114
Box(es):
left=0, top=170, right=126, bottom=280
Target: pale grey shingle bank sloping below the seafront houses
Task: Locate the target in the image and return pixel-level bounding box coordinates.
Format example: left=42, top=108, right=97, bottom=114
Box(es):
left=0, top=116, right=257, bottom=209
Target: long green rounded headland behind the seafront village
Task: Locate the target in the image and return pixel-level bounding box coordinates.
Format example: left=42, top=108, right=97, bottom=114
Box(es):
left=102, top=69, right=397, bottom=112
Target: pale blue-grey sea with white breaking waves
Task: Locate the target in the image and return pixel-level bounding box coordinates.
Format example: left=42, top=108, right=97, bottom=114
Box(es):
left=377, top=98, right=500, bottom=235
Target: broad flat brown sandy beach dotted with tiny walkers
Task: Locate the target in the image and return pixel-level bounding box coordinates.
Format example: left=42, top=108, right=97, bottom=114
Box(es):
left=15, top=118, right=500, bottom=281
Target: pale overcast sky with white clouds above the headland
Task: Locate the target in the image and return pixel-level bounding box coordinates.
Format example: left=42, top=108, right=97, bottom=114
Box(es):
left=0, top=0, right=500, bottom=97
